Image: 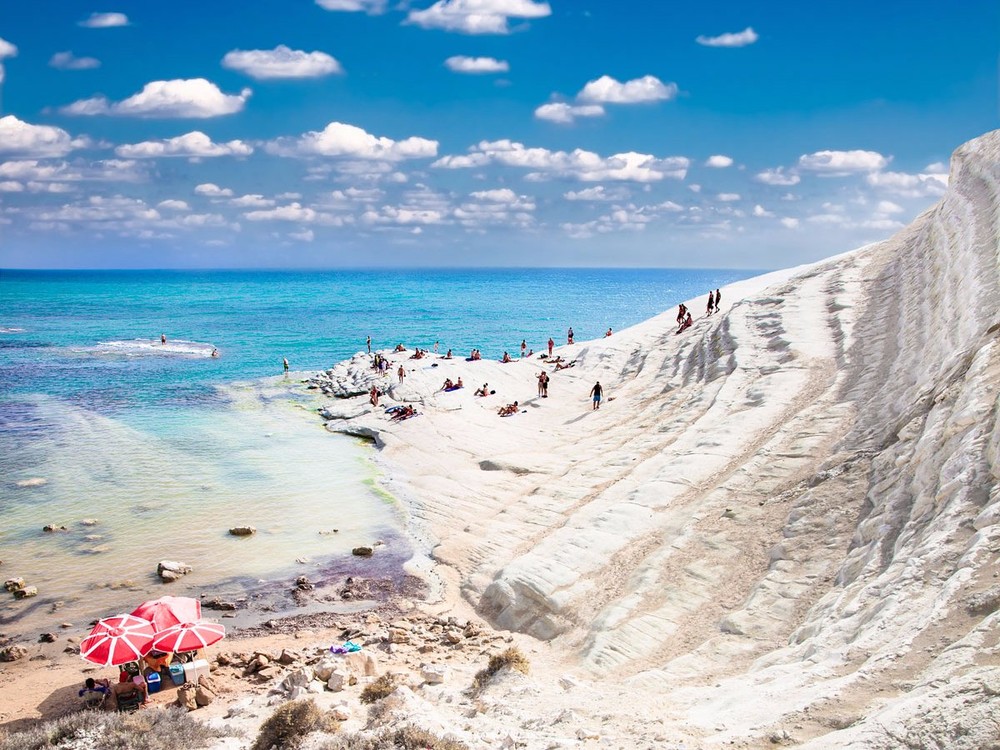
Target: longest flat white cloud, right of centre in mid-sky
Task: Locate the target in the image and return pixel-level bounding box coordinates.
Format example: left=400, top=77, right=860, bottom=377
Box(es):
left=431, top=140, right=690, bottom=187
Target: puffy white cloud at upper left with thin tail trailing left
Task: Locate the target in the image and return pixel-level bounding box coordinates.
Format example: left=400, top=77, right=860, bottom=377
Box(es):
left=60, top=78, right=252, bottom=118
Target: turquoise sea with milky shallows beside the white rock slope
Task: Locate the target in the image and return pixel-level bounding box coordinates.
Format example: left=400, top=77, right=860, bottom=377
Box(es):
left=0, top=269, right=757, bottom=638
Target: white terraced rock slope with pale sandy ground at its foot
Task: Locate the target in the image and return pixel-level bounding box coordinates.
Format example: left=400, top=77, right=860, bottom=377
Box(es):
left=0, top=132, right=1000, bottom=749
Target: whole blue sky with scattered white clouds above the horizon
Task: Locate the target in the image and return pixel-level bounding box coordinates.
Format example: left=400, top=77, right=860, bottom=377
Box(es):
left=0, top=0, right=1000, bottom=268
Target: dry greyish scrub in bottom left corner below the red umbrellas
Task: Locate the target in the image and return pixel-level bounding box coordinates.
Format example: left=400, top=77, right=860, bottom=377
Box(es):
left=0, top=708, right=224, bottom=750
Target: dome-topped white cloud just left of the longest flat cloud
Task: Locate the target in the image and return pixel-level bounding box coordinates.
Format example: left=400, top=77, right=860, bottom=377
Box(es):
left=266, top=122, right=438, bottom=161
